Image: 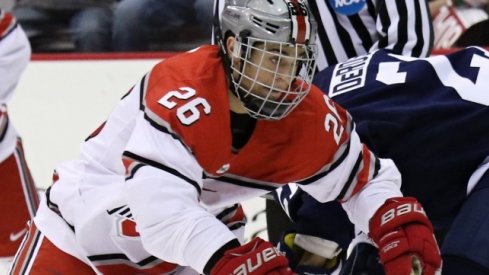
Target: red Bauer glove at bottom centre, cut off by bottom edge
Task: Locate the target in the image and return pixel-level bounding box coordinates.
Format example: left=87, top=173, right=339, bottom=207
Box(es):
left=210, top=237, right=295, bottom=275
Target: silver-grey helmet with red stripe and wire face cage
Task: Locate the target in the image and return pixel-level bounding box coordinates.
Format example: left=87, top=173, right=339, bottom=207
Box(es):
left=215, top=0, right=317, bottom=120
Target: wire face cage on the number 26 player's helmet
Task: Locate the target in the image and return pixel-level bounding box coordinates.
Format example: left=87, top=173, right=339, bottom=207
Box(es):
left=229, top=35, right=316, bottom=120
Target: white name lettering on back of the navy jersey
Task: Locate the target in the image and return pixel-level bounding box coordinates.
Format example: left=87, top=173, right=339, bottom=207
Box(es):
left=329, top=55, right=372, bottom=97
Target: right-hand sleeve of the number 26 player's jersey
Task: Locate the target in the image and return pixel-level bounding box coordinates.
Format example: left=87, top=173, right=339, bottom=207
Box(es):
left=297, top=95, right=402, bottom=235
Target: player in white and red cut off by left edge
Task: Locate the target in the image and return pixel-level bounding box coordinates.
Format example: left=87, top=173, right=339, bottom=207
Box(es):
left=0, top=9, right=39, bottom=261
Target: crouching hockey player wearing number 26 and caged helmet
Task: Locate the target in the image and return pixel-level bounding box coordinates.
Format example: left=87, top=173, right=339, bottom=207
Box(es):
left=11, top=0, right=441, bottom=275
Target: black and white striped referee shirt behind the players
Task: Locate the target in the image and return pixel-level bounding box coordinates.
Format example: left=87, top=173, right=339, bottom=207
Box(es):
left=214, top=0, right=434, bottom=70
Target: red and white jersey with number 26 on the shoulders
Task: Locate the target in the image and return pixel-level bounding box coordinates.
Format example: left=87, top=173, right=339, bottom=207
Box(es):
left=34, top=46, right=401, bottom=274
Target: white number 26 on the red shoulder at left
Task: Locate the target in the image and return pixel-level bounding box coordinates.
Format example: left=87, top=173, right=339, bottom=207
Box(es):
left=158, top=87, right=211, bottom=125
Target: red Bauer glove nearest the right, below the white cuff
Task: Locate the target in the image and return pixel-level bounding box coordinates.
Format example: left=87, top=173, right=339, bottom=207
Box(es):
left=369, top=197, right=441, bottom=275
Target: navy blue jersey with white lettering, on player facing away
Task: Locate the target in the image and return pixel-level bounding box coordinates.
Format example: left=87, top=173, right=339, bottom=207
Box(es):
left=315, top=48, right=489, bottom=227
